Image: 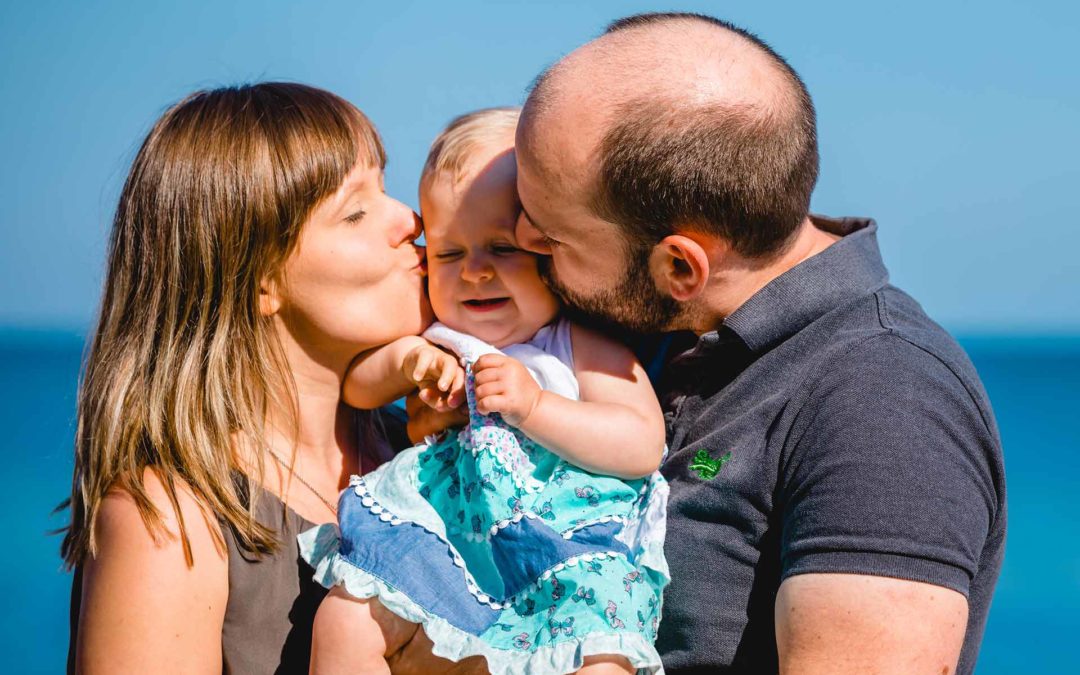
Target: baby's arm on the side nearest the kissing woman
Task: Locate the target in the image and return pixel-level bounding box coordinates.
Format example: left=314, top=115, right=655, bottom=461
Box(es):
left=342, top=335, right=465, bottom=410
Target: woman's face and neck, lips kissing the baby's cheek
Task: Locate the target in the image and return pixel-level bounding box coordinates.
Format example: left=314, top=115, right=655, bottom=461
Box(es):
left=260, top=158, right=432, bottom=509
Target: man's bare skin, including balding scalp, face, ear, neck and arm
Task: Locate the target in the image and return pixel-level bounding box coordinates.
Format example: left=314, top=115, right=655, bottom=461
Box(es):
left=507, top=15, right=968, bottom=675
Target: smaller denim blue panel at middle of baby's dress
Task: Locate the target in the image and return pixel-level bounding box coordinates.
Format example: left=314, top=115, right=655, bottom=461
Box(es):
left=491, top=518, right=630, bottom=595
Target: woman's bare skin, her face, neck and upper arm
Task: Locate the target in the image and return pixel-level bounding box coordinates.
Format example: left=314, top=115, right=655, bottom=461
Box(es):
left=77, top=155, right=431, bottom=673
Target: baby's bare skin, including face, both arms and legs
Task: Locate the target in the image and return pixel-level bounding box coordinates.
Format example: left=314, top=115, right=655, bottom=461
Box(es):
left=326, top=134, right=664, bottom=675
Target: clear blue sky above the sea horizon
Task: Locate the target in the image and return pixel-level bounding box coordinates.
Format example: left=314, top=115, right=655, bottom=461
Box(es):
left=0, top=0, right=1080, bottom=334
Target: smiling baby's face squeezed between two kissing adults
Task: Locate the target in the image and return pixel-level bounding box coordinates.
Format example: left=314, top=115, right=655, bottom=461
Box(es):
left=420, top=147, right=558, bottom=347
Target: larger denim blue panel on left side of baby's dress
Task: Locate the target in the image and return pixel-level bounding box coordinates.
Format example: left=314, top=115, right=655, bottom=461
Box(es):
left=338, top=490, right=498, bottom=635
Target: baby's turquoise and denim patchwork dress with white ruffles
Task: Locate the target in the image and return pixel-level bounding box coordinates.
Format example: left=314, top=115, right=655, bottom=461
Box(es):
left=300, top=320, right=669, bottom=675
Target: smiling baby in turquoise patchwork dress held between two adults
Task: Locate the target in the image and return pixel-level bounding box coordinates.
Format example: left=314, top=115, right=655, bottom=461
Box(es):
left=300, top=108, right=667, bottom=675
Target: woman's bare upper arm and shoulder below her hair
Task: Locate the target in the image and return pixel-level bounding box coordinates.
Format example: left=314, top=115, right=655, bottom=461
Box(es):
left=76, top=470, right=229, bottom=675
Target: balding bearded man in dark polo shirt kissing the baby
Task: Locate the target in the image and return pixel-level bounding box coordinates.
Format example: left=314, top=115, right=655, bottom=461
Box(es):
left=509, top=14, right=1005, bottom=674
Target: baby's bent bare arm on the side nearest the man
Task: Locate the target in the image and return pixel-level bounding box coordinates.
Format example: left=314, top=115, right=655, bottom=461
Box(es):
left=473, top=325, right=664, bottom=478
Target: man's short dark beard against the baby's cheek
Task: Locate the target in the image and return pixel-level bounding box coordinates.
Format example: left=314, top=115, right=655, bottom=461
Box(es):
left=537, top=249, right=684, bottom=335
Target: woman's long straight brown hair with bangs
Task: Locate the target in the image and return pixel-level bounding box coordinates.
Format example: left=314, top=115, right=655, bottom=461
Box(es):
left=62, top=82, right=386, bottom=567
